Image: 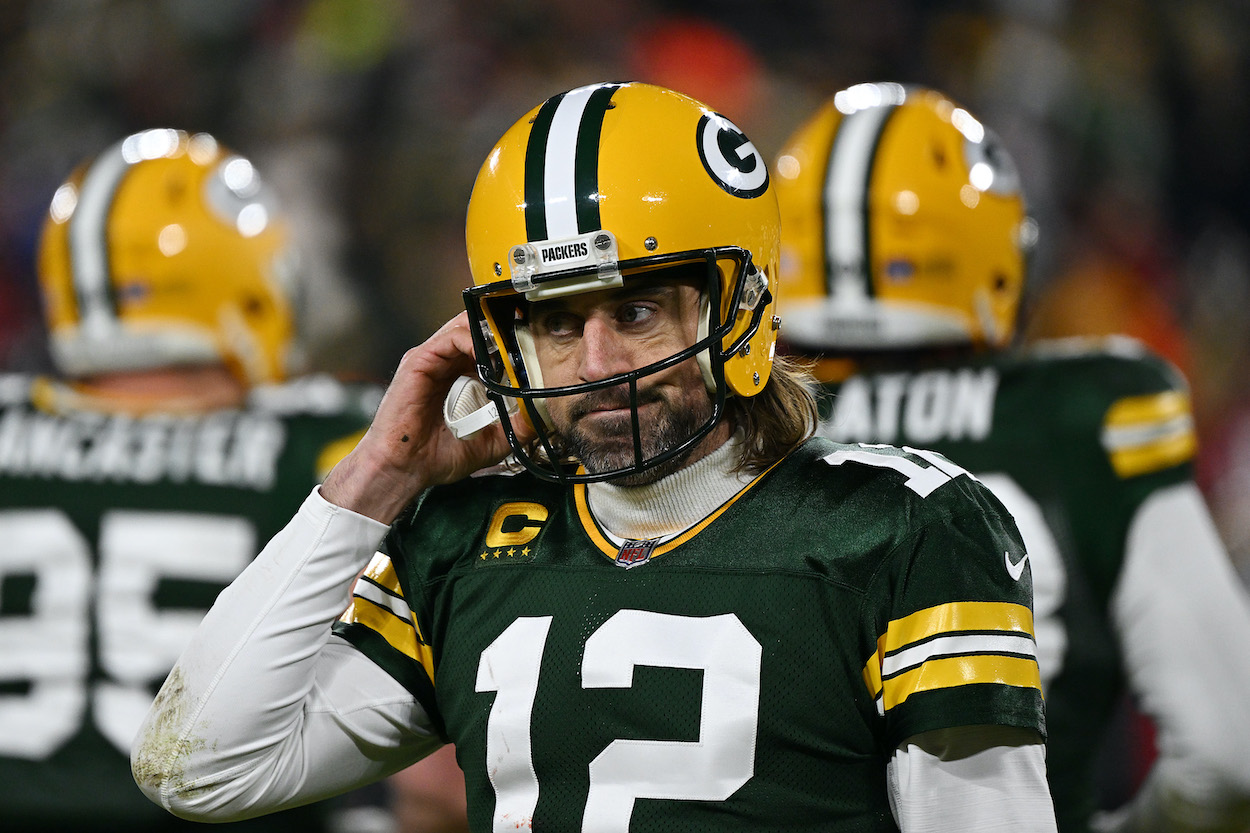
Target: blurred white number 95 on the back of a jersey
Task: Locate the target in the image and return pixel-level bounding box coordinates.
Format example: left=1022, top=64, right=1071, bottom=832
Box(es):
left=0, top=509, right=256, bottom=760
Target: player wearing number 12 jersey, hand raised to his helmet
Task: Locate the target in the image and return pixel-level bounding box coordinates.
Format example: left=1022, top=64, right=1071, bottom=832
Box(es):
left=133, top=84, right=1054, bottom=832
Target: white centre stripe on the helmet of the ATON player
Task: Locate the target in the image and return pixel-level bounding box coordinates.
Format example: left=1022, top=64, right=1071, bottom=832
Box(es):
left=824, top=106, right=894, bottom=303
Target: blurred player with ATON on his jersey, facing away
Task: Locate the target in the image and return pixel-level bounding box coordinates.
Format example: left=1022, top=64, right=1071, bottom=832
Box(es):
left=776, top=84, right=1250, bottom=833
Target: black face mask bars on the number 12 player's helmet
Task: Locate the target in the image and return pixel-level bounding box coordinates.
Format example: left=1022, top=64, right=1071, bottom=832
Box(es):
left=465, top=248, right=768, bottom=483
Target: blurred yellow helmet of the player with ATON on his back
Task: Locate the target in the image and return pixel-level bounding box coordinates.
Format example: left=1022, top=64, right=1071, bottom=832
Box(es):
left=774, top=84, right=1036, bottom=351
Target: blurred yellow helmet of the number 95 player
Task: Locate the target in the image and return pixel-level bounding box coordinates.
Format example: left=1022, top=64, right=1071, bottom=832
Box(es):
left=39, top=129, right=295, bottom=384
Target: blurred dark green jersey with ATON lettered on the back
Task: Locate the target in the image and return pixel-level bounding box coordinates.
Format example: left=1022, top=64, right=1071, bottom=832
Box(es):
left=821, top=339, right=1194, bottom=832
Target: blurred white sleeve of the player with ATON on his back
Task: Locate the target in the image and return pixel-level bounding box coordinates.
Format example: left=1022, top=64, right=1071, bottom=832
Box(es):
left=1098, top=483, right=1250, bottom=833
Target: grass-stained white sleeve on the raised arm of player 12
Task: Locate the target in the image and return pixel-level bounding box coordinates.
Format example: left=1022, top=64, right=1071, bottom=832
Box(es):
left=131, top=492, right=441, bottom=822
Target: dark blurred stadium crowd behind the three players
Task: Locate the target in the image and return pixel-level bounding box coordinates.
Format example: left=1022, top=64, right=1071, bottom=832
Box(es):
left=0, top=0, right=1250, bottom=578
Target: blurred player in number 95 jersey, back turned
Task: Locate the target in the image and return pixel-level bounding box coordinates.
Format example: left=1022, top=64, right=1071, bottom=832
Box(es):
left=0, top=130, right=379, bottom=833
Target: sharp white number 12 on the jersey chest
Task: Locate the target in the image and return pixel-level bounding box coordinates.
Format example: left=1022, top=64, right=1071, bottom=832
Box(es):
left=478, top=610, right=761, bottom=833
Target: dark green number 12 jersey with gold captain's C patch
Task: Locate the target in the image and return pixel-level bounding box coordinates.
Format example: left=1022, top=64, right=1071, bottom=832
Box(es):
left=336, top=430, right=1044, bottom=833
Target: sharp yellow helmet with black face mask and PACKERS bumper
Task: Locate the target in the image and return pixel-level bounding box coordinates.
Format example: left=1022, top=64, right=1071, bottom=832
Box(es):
left=465, top=83, right=779, bottom=480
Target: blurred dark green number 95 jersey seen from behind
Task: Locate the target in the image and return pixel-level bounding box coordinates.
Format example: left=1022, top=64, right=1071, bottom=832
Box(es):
left=0, top=375, right=378, bottom=833
